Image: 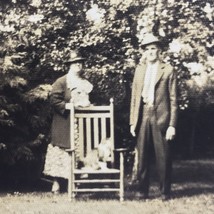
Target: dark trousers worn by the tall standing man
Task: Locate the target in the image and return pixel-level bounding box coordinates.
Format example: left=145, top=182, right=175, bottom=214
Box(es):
left=137, top=104, right=172, bottom=195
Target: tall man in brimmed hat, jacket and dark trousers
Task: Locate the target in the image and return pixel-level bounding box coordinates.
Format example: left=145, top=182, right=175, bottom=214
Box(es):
left=130, top=34, right=177, bottom=200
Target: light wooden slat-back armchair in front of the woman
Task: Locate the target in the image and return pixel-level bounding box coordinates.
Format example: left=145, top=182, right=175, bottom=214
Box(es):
left=66, top=99, right=125, bottom=201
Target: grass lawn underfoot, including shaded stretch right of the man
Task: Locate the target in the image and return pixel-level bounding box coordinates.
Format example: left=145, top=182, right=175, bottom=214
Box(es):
left=0, top=159, right=214, bottom=214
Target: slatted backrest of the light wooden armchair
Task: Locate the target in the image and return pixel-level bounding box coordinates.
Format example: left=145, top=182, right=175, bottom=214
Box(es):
left=66, top=99, right=114, bottom=162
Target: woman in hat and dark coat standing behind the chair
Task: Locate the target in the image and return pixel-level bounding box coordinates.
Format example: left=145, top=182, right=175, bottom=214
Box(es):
left=43, top=51, right=93, bottom=193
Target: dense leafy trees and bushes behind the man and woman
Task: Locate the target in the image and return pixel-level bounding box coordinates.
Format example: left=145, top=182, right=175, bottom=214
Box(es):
left=0, top=0, right=214, bottom=183
